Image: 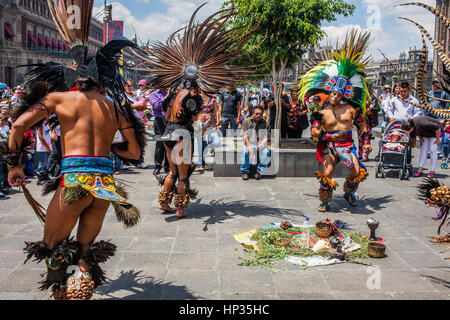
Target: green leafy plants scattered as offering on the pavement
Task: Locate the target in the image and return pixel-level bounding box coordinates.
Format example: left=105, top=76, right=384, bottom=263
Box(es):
left=239, top=227, right=369, bottom=269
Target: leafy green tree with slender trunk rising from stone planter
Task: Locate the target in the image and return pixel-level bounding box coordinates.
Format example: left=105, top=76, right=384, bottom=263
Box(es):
left=223, top=0, right=355, bottom=136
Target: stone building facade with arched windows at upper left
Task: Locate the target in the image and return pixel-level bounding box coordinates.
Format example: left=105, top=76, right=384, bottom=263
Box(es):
left=0, top=0, right=142, bottom=87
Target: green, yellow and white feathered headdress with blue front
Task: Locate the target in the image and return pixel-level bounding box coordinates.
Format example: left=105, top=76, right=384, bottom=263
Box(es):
left=299, top=29, right=370, bottom=114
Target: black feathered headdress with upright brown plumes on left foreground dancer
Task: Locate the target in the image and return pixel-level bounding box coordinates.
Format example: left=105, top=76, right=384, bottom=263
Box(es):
left=13, top=0, right=146, bottom=162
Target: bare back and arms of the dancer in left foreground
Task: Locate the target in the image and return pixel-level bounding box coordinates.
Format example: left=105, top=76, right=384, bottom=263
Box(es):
left=8, top=90, right=141, bottom=186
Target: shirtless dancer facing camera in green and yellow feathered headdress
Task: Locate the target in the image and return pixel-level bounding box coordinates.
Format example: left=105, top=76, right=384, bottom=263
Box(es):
left=299, top=31, right=371, bottom=212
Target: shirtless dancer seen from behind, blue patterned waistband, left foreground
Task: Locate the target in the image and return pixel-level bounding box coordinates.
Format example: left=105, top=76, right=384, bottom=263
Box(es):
left=1, top=0, right=143, bottom=299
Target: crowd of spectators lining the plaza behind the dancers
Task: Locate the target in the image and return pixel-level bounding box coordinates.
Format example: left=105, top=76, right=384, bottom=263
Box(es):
left=0, top=79, right=450, bottom=198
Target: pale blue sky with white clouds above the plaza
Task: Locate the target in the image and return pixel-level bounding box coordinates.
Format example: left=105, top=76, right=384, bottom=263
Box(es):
left=94, top=0, right=436, bottom=60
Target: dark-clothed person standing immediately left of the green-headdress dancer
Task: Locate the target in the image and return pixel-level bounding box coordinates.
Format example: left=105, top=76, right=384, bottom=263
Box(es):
left=286, top=89, right=309, bottom=139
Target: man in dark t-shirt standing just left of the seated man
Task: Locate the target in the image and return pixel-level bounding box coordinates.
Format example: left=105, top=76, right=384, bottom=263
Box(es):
left=217, top=85, right=242, bottom=137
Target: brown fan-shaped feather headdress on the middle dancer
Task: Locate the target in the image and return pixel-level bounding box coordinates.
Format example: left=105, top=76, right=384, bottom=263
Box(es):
left=147, top=3, right=258, bottom=94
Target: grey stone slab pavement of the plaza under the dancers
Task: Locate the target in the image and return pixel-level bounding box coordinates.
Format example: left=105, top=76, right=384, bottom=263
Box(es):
left=0, top=133, right=450, bottom=300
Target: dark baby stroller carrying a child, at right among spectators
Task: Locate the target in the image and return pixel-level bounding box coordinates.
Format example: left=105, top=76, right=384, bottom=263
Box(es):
left=375, top=121, right=412, bottom=180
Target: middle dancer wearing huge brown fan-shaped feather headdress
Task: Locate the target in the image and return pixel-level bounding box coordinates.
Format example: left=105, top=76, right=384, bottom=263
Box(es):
left=148, top=4, right=256, bottom=218
